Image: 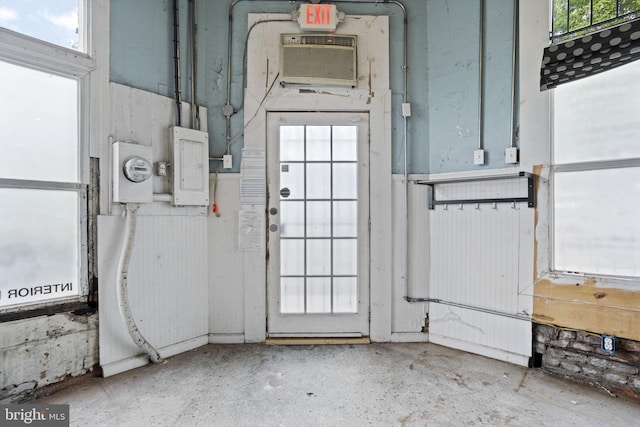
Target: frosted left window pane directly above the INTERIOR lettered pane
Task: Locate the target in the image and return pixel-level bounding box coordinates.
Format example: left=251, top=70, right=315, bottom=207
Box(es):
left=0, top=61, right=79, bottom=182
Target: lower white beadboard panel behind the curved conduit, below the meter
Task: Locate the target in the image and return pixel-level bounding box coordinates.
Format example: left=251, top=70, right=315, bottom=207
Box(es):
left=98, top=216, right=208, bottom=366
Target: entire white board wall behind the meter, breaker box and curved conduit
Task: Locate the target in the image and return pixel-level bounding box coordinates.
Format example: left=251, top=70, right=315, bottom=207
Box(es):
left=98, top=83, right=209, bottom=376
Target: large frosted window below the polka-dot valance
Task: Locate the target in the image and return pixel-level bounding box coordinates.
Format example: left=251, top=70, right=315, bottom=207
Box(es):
left=553, top=57, right=640, bottom=277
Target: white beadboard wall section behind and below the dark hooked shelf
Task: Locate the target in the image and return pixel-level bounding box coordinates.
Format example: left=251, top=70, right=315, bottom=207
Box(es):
left=429, top=179, right=531, bottom=362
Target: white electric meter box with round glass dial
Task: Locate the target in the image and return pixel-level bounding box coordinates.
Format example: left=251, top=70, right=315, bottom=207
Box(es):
left=113, top=142, right=153, bottom=203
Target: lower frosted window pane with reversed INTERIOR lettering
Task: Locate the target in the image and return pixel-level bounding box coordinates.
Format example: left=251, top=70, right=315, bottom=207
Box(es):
left=0, top=189, right=80, bottom=307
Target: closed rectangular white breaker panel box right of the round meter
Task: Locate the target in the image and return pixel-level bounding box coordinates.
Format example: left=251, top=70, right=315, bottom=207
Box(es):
left=169, top=126, right=209, bottom=206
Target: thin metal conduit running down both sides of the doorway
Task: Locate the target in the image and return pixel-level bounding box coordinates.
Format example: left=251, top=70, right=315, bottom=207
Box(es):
left=228, top=0, right=415, bottom=302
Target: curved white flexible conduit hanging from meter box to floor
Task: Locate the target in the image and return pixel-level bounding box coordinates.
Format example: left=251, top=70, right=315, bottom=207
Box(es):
left=116, top=203, right=162, bottom=363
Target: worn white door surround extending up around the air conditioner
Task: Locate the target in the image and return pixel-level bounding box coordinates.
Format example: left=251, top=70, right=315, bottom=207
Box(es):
left=242, top=14, right=390, bottom=342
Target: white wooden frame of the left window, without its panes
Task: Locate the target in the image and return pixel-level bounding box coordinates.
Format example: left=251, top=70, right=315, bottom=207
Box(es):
left=0, top=0, right=97, bottom=322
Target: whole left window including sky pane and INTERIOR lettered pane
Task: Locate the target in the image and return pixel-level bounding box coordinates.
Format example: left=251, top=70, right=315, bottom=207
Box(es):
left=0, top=0, right=94, bottom=313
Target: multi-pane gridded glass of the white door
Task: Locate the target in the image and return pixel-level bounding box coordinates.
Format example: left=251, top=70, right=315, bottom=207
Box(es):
left=279, top=126, right=358, bottom=314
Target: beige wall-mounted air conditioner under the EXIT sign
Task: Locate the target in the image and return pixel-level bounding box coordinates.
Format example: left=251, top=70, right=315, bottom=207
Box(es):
left=280, top=34, right=358, bottom=87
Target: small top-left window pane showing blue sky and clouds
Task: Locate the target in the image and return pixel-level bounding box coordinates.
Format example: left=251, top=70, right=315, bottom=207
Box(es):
left=0, top=0, right=80, bottom=49
